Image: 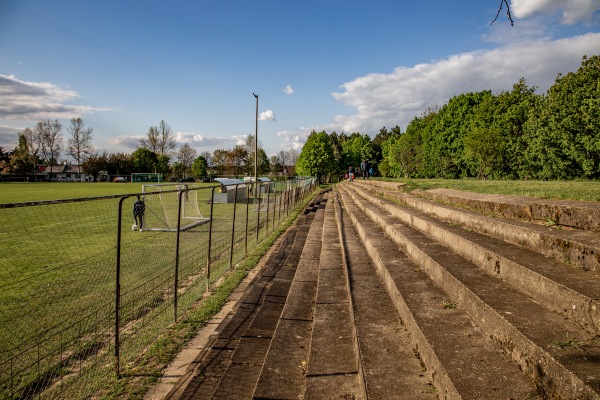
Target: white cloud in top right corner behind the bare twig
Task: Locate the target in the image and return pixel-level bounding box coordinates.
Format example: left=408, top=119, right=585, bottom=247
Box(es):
left=511, top=0, right=600, bottom=25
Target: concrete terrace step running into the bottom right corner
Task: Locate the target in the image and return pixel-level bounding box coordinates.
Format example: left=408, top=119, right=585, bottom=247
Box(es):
left=340, top=184, right=600, bottom=399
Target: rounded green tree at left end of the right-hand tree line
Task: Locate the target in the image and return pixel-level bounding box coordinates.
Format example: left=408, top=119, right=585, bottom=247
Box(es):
left=296, top=131, right=335, bottom=180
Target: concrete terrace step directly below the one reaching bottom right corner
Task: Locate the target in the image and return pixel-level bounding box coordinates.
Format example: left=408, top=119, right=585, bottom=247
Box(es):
left=342, top=186, right=535, bottom=399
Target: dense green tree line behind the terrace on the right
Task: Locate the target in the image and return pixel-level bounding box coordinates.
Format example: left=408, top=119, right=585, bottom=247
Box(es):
left=297, top=56, right=600, bottom=180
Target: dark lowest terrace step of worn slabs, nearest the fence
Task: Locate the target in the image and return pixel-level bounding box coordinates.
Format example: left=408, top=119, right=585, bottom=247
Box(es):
left=169, top=194, right=330, bottom=399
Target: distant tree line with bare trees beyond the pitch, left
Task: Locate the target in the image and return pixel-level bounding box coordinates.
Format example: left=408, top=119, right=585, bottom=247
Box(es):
left=0, top=118, right=298, bottom=178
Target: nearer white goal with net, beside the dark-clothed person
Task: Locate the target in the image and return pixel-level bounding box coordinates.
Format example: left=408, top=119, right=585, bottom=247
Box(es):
left=142, top=183, right=210, bottom=232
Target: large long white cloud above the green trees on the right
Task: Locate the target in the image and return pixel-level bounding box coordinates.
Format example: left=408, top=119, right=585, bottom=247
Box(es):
left=328, top=33, right=600, bottom=134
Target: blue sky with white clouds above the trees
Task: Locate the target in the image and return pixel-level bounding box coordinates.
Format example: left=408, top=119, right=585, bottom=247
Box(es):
left=0, top=0, right=600, bottom=158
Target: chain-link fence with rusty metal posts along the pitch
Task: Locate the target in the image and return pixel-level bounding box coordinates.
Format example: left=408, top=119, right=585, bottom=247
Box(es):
left=0, top=178, right=316, bottom=399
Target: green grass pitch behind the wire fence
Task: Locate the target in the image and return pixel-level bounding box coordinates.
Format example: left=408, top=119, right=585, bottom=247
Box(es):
left=0, top=183, right=300, bottom=398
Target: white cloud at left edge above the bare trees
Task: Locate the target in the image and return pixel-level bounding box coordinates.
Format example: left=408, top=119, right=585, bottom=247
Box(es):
left=0, top=74, right=110, bottom=121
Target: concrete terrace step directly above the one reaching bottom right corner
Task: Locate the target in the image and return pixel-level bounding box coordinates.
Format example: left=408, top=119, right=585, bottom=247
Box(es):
left=355, top=183, right=600, bottom=334
